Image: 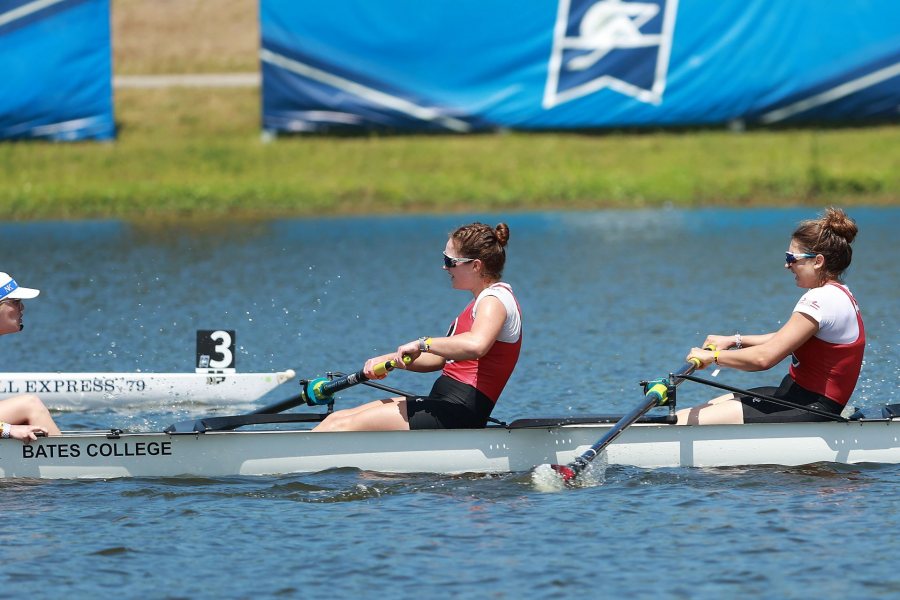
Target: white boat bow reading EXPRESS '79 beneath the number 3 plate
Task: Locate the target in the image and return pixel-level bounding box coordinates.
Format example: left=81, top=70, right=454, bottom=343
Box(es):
left=0, top=369, right=295, bottom=411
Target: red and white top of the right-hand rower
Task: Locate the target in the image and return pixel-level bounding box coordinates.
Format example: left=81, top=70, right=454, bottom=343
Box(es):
left=790, top=283, right=866, bottom=406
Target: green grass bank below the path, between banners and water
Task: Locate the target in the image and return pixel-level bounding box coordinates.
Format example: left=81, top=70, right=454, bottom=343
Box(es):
left=0, top=89, right=900, bottom=219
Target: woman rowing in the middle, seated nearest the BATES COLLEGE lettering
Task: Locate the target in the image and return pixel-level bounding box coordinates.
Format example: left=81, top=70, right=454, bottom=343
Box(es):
left=315, top=223, right=522, bottom=431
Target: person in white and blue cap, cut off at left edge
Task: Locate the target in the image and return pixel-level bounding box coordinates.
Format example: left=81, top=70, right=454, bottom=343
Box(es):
left=0, top=273, right=59, bottom=443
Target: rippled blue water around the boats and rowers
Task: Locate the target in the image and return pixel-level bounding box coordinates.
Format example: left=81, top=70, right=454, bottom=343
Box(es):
left=0, top=208, right=900, bottom=598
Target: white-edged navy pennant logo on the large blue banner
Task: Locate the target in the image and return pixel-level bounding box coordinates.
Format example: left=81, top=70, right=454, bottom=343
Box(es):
left=543, top=0, right=678, bottom=109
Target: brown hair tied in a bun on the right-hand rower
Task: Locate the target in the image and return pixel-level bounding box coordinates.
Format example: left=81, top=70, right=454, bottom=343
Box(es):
left=791, top=207, right=859, bottom=280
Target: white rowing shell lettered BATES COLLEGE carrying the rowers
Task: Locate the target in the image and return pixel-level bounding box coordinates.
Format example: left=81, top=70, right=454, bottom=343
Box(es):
left=0, top=417, right=900, bottom=479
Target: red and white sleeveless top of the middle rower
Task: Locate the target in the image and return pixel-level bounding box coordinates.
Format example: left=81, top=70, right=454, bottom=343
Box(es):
left=443, top=283, right=522, bottom=404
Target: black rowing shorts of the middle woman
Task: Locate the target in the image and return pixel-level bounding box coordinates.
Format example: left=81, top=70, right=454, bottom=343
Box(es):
left=406, top=375, right=494, bottom=429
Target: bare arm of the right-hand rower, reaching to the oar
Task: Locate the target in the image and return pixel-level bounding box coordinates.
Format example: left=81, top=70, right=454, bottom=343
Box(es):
left=688, top=312, right=819, bottom=371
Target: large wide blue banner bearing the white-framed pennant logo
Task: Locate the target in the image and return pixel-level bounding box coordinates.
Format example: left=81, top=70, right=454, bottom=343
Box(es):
left=260, top=0, right=900, bottom=132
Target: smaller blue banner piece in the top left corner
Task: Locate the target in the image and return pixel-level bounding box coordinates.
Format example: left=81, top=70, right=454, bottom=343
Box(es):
left=0, top=0, right=115, bottom=140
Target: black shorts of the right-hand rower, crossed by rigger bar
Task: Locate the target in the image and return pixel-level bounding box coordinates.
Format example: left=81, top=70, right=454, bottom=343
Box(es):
left=737, top=375, right=844, bottom=423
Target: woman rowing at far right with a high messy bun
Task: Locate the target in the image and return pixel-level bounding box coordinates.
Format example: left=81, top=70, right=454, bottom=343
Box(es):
left=678, top=208, right=866, bottom=425
